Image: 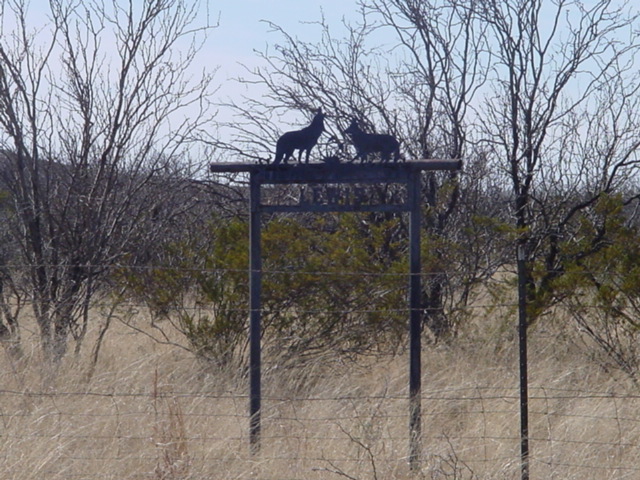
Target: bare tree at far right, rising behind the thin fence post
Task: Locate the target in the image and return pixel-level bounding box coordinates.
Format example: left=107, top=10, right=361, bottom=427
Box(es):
left=477, top=0, right=640, bottom=322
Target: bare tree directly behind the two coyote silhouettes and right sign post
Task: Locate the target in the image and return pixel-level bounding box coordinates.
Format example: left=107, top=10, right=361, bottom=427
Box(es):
left=214, top=0, right=490, bottom=337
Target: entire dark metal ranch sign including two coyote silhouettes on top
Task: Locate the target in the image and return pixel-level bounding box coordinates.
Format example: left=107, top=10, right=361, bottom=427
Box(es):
left=210, top=110, right=461, bottom=467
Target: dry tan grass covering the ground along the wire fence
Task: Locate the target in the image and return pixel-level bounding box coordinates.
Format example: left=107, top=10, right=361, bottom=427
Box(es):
left=0, top=308, right=640, bottom=480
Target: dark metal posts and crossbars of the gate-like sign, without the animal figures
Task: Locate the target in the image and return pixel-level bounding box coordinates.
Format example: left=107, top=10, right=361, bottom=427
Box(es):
left=211, top=160, right=461, bottom=467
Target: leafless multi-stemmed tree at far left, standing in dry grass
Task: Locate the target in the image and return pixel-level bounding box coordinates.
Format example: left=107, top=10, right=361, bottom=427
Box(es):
left=0, top=0, right=212, bottom=360
